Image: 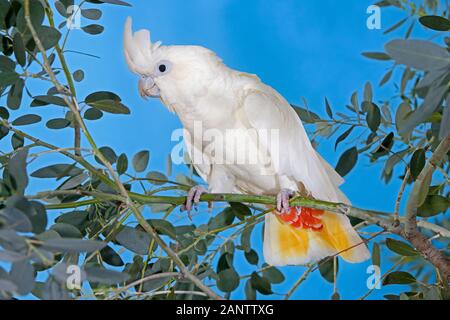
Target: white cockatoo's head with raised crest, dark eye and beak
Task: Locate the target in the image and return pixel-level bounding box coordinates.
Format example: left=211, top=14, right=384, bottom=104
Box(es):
left=124, top=17, right=223, bottom=106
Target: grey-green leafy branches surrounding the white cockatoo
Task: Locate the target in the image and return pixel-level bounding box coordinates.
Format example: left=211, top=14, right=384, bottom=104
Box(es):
left=0, top=0, right=450, bottom=299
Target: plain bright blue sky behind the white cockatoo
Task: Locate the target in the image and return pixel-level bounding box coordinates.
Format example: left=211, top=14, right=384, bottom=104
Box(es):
left=2, top=0, right=440, bottom=299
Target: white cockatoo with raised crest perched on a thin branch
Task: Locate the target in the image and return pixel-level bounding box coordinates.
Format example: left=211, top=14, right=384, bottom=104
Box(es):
left=124, top=18, right=369, bottom=266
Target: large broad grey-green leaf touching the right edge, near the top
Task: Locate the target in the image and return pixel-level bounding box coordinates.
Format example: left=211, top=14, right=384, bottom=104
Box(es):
left=385, top=40, right=450, bottom=71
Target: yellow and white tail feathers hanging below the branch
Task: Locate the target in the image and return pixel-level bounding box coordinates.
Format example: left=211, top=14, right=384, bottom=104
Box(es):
left=264, top=212, right=370, bottom=266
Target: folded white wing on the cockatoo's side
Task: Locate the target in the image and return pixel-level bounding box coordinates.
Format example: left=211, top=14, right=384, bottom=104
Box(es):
left=242, top=82, right=348, bottom=202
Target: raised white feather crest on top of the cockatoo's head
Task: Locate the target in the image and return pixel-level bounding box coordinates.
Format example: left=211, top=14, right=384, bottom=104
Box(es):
left=124, top=17, right=161, bottom=75
